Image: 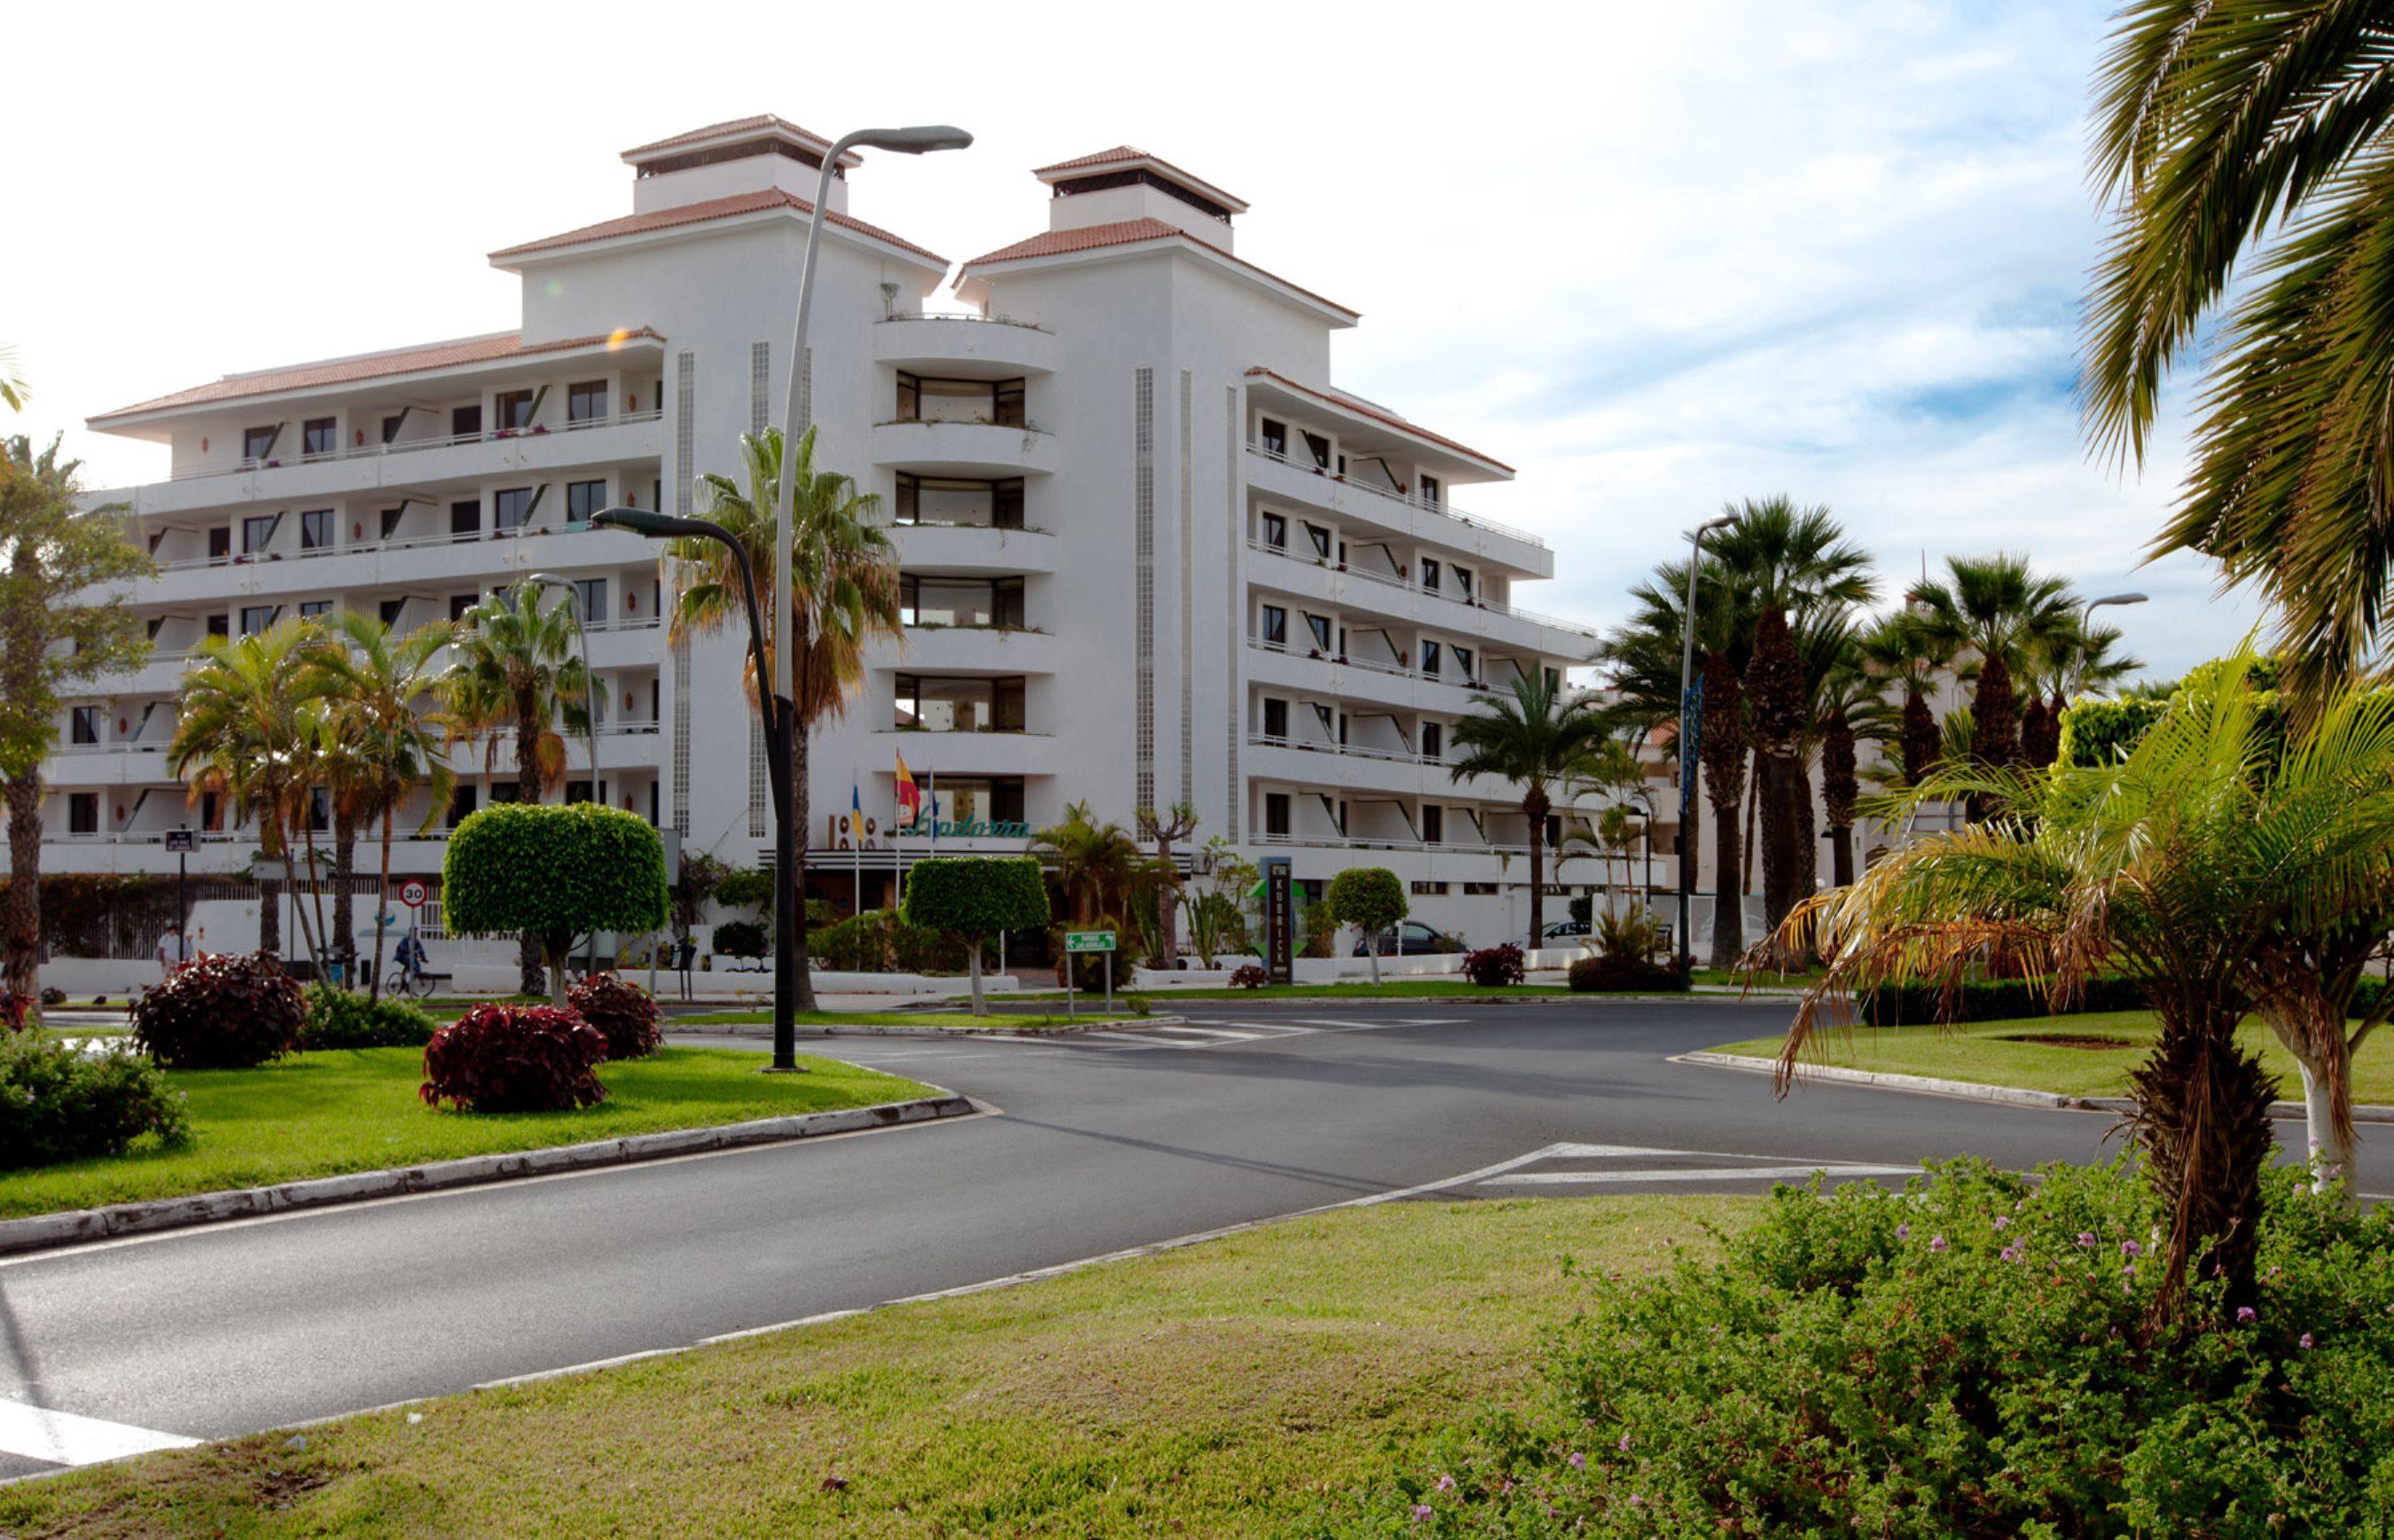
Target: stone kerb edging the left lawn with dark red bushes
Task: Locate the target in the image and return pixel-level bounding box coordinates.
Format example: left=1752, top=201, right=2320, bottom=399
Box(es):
left=0, top=1087, right=979, bottom=1255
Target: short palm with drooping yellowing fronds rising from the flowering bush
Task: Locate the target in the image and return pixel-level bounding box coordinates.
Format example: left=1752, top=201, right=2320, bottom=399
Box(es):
left=1781, top=653, right=2394, bottom=1308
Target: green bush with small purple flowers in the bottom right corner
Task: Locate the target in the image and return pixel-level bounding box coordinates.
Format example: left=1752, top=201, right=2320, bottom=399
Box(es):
left=1372, top=1161, right=2394, bottom=1537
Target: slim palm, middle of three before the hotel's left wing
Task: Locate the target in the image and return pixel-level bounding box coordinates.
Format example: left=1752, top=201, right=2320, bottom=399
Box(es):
left=321, top=611, right=457, bottom=998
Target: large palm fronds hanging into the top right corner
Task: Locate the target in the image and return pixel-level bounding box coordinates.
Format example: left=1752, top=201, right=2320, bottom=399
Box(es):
left=2080, top=0, right=2394, bottom=692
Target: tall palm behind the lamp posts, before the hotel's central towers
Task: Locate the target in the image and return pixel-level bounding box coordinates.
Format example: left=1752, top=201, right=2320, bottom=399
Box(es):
left=666, top=429, right=905, bottom=1011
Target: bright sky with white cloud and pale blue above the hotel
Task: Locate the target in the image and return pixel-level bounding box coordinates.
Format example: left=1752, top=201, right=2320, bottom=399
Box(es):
left=0, top=0, right=2260, bottom=673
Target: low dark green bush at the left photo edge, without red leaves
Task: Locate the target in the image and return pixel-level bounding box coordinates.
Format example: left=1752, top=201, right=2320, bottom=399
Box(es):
left=0, top=1037, right=192, bottom=1171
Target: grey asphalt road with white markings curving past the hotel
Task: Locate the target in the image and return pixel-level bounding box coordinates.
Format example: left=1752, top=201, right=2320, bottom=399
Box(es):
left=0, top=998, right=2355, bottom=1475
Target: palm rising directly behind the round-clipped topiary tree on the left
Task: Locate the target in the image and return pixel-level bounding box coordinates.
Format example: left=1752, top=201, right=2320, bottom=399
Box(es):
left=441, top=582, right=598, bottom=994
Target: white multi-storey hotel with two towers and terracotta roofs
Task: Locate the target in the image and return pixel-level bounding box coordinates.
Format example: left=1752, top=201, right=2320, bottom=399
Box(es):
left=43, top=117, right=1600, bottom=946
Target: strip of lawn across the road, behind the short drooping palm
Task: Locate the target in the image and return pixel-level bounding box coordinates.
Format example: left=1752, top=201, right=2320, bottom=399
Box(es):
left=1714, top=1011, right=2394, bottom=1104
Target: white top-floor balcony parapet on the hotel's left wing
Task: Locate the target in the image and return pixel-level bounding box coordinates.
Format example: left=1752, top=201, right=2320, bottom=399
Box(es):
left=127, top=412, right=666, bottom=518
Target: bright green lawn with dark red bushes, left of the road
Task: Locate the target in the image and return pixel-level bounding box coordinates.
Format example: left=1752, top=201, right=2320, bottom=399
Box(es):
left=0, top=1047, right=929, bottom=1219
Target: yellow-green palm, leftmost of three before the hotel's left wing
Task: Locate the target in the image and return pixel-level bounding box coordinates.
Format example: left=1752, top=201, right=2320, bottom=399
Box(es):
left=168, top=615, right=325, bottom=967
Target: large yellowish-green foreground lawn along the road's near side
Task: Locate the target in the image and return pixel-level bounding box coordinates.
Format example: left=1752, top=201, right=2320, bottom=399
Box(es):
left=0, top=1198, right=1762, bottom=1540
